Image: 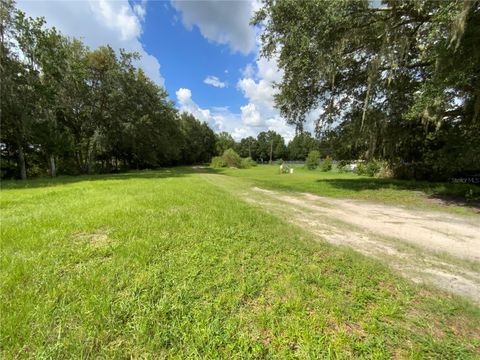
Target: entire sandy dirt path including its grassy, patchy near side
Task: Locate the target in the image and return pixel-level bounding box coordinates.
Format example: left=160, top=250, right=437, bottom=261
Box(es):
left=205, top=175, right=480, bottom=304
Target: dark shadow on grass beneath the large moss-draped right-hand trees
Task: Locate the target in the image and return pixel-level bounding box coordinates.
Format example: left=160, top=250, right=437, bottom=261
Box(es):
left=317, top=177, right=480, bottom=209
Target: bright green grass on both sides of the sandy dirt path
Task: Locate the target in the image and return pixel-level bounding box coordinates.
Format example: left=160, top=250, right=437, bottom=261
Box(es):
left=0, top=167, right=480, bottom=359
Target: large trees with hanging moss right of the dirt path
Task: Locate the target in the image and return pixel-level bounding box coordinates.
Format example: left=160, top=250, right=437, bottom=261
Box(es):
left=252, top=0, right=480, bottom=179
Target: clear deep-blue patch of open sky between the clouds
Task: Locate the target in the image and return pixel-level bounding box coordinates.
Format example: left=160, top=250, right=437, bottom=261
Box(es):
left=141, top=2, right=256, bottom=113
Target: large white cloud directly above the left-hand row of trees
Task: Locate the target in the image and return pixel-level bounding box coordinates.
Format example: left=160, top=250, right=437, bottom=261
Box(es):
left=17, top=0, right=164, bottom=85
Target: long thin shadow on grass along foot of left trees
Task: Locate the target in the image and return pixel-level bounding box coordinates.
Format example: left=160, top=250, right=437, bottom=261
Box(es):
left=0, top=166, right=219, bottom=190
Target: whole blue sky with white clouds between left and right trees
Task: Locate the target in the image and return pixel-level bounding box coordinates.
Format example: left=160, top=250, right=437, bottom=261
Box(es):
left=17, top=0, right=316, bottom=141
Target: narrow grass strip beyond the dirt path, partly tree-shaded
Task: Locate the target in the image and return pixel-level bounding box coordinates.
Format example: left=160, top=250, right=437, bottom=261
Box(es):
left=222, top=165, right=480, bottom=214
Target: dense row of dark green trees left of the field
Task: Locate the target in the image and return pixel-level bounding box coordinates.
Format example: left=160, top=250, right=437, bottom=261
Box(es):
left=0, top=0, right=221, bottom=179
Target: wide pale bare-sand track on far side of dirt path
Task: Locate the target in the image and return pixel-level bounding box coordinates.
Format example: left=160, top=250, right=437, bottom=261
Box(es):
left=253, top=188, right=480, bottom=262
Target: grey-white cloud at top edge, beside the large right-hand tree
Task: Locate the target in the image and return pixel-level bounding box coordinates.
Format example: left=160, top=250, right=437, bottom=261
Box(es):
left=172, top=0, right=256, bottom=54
